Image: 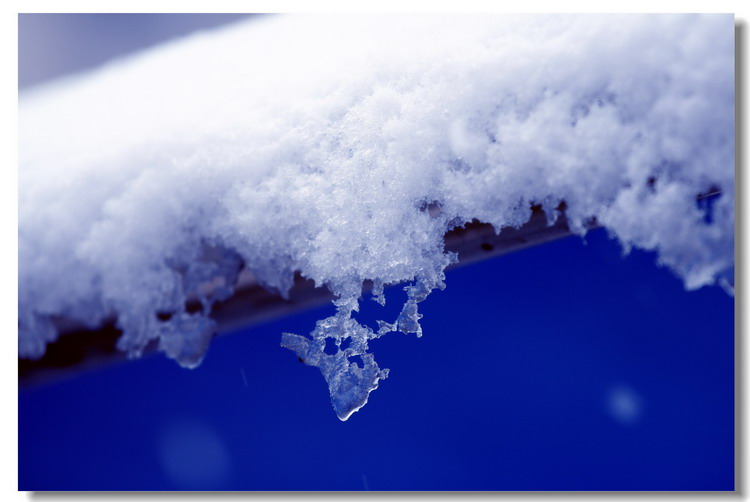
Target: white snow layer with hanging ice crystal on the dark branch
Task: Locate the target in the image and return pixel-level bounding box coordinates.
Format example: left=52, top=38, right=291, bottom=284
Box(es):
left=18, top=15, right=734, bottom=420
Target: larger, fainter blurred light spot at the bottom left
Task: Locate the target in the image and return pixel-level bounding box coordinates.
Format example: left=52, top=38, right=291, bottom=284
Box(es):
left=157, top=418, right=230, bottom=490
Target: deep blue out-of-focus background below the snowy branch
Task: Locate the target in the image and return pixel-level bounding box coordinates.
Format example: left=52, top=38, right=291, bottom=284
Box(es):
left=19, top=231, right=734, bottom=490
